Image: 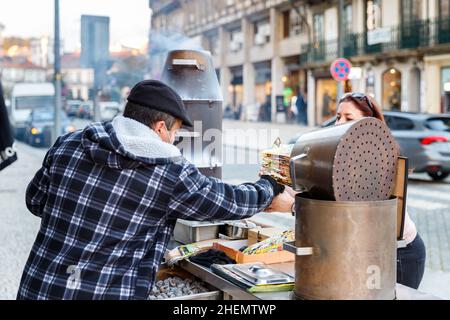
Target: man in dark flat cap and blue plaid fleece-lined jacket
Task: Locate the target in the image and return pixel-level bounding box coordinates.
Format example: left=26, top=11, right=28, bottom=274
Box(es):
left=17, top=81, right=292, bottom=300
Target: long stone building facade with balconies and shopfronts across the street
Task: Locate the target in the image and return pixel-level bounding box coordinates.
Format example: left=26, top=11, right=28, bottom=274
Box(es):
left=150, top=0, right=450, bottom=125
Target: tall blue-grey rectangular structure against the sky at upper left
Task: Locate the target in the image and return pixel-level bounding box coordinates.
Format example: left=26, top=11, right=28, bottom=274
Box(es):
left=81, top=15, right=110, bottom=90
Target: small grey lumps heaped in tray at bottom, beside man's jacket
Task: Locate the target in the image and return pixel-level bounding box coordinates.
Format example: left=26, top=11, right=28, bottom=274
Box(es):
left=148, top=277, right=209, bottom=300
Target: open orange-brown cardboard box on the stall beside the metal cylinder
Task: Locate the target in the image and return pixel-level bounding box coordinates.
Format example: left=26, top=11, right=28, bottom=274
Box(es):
left=214, top=240, right=295, bottom=264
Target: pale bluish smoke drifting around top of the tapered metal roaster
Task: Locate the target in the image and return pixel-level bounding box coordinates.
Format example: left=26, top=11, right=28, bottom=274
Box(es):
left=149, top=31, right=204, bottom=80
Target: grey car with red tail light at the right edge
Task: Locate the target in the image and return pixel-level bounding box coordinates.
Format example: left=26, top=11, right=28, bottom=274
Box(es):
left=291, top=111, right=450, bottom=181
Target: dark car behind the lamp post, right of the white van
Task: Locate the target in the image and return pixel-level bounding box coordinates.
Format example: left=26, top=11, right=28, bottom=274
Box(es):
left=25, top=108, right=75, bottom=146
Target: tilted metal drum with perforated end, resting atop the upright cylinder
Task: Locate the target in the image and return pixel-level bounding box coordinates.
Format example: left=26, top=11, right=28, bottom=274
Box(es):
left=290, top=118, right=399, bottom=201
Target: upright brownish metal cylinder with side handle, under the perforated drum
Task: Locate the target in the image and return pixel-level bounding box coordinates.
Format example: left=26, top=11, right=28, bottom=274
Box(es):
left=285, top=194, right=397, bottom=300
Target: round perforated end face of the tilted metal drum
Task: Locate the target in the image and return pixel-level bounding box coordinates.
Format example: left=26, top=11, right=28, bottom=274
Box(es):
left=332, top=118, right=399, bottom=201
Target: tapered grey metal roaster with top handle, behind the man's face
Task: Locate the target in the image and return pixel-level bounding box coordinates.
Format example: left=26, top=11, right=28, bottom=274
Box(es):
left=161, top=50, right=223, bottom=178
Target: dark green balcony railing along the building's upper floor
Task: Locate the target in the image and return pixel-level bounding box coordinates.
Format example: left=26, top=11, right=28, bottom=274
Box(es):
left=300, top=17, right=450, bottom=64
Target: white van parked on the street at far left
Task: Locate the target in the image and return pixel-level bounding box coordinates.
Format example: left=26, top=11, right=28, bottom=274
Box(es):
left=10, top=83, right=55, bottom=139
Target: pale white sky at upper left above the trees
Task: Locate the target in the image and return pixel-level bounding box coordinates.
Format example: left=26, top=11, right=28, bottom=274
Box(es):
left=0, top=0, right=150, bottom=52
